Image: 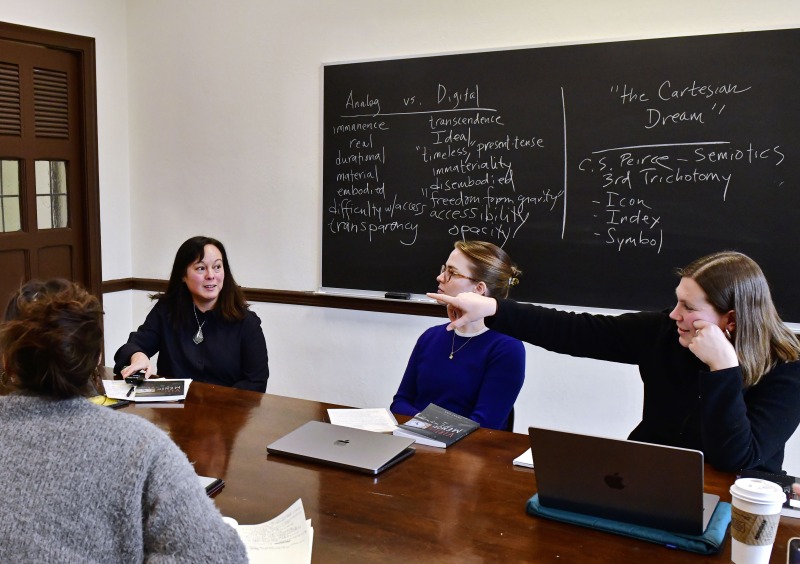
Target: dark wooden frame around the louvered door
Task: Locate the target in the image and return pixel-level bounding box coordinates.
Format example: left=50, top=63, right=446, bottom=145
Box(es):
left=0, top=22, right=103, bottom=303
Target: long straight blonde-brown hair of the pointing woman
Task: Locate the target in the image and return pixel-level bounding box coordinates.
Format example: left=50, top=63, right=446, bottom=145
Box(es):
left=678, top=251, right=800, bottom=387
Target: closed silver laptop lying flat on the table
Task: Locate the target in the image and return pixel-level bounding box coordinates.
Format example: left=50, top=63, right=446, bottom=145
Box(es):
left=267, top=421, right=414, bottom=474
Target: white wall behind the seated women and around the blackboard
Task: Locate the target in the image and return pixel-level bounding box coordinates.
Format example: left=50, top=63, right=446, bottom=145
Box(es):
left=0, top=0, right=800, bottom=474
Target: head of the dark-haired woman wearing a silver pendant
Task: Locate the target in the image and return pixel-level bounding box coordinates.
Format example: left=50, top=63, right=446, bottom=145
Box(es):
left=153, top=236, right=247, bottom=324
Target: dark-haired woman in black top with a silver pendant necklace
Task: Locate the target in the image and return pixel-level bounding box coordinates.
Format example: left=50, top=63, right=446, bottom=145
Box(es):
left=114, top=237, right=269, bottom=393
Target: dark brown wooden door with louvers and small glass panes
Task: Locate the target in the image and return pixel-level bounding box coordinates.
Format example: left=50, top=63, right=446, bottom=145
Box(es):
left=0, top=24, right=100, bottom=308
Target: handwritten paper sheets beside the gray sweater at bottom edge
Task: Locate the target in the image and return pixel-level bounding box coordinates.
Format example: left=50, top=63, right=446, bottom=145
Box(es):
left=236, top=499, right=314, bottom=564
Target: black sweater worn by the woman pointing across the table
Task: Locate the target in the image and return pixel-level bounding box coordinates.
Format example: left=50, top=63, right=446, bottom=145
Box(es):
left=486, top=300, right=800, bottom=472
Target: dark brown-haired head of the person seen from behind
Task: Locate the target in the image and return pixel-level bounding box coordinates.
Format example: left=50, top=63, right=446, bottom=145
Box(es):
left=0, top=279, right=103, bottom=399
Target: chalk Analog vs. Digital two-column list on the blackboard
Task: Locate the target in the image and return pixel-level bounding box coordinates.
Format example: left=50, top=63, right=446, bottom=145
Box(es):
left=327, top=83, right=563, bottom=245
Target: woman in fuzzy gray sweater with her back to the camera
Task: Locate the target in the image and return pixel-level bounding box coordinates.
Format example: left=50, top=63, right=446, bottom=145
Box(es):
left=0, top=280, right=247, bottom=562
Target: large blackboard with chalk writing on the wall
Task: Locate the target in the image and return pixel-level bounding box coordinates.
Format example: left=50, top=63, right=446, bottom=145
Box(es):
left=322, top=29, right=800, bottom=322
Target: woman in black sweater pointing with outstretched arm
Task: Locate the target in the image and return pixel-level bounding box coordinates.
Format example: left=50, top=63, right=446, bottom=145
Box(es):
left=428, top=252, right=800, bottom=472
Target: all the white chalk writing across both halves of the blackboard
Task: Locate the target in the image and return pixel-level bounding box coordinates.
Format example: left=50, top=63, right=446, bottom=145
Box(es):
left=327, top=80, right=784, bottom=253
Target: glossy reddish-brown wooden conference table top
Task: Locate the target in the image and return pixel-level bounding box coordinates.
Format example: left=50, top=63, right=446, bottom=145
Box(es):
left=123, top=382, right=800, bottom=563
